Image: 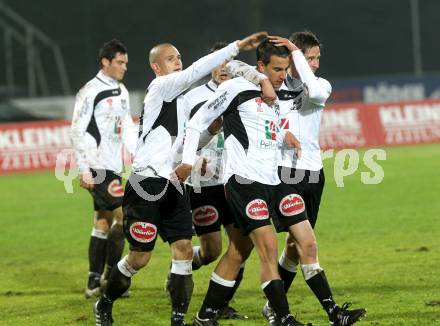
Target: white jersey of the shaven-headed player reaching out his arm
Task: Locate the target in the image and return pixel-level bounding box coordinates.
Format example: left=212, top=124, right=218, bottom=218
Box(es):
left=133, top=42, right=239, bottom=179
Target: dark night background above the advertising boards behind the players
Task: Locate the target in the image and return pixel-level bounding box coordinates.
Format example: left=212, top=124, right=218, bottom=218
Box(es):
left=0, top=0, right=440, bottom=93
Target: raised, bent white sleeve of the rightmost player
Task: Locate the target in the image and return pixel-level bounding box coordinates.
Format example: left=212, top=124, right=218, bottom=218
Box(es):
left=292, top=50, right=331, bottom=106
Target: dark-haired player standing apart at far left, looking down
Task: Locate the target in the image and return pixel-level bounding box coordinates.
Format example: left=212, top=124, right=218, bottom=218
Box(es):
left=71, top=40, right=137, bottom=298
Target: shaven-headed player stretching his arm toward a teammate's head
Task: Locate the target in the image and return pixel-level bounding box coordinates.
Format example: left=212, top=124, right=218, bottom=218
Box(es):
left=94, top=32, right=267, bottom=326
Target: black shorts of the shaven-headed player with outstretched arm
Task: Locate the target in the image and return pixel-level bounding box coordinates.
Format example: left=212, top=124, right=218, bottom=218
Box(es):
left=122, top=174, right=194, bottom=251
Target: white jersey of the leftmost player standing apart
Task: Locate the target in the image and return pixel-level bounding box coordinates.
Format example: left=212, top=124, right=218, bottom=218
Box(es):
left=71, top=71, right=137, bottom=173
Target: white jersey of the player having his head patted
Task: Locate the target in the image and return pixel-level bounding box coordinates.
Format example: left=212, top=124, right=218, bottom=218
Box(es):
left=182, top=77, right=300, bottom=185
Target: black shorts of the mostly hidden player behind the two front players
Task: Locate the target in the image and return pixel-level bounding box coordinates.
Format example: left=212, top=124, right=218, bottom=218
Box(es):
left=188, top=185, right=234, bottom=236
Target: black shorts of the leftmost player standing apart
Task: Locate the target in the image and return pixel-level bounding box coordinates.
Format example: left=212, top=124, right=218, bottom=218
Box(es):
left=90, top=169, right=124, bottom=211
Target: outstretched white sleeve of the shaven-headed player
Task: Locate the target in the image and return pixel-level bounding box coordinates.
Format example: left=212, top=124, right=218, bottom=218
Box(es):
left=157, top=41, right=239, bottom=102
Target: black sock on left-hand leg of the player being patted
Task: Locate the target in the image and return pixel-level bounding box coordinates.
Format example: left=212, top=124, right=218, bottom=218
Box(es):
left=199, top=280, right=233, bottom=319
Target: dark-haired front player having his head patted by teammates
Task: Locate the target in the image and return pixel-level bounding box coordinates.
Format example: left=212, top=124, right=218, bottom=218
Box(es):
left=175, top=40, right=307, bottom=326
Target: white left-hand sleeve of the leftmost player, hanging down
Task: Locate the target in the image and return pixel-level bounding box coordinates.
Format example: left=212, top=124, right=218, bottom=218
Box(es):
left=70, top=85, right=94, bottom=172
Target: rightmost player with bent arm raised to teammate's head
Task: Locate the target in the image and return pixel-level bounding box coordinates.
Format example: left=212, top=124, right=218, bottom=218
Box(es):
left=263, top=32, right=366, bottom=326
